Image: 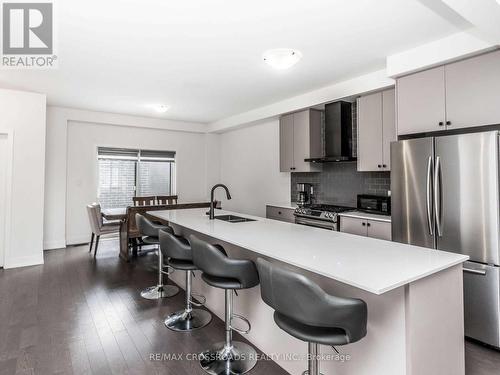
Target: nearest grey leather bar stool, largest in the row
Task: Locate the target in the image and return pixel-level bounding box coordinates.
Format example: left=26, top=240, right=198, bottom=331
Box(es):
left=257, top=258, right=367, bottom=375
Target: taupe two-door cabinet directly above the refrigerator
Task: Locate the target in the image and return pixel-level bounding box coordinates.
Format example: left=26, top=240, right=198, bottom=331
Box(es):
left=396, top=51, right=500, bottom=135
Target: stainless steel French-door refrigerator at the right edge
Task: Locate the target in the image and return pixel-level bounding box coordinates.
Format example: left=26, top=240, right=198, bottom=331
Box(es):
left=391, top=131, right=500, bottom=347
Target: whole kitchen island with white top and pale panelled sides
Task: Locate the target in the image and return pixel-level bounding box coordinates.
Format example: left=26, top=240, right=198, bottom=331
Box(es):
left=149, top=209, right=468, bottom=375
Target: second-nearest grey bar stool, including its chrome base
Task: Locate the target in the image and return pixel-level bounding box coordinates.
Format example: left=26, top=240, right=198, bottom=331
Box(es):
left=189, top=235, right=259, bottom=375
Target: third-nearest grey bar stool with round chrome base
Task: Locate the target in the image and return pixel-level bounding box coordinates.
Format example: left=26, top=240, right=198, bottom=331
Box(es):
left=160, top=230, right=212, bottom=332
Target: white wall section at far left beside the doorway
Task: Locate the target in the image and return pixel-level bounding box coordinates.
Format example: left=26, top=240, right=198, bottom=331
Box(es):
left=0, top=89, right=46, bottom=268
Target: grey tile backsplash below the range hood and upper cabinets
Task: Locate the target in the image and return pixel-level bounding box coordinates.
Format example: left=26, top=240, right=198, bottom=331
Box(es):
left=291, top=162, right=391, bottom=207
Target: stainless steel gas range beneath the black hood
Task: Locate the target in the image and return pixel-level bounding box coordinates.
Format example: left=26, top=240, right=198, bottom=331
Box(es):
left=294, top=204, right=355, bottom=231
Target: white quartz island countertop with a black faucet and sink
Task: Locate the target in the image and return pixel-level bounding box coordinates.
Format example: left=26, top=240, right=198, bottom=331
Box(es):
left=148, top=208, right=468, bottom=294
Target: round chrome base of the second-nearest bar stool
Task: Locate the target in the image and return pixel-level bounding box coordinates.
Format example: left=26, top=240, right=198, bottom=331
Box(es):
left=200, top=341, right=257, bottom=375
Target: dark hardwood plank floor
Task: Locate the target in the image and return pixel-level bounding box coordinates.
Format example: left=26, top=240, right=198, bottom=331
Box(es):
left=0, top=240, right=500, bottom=375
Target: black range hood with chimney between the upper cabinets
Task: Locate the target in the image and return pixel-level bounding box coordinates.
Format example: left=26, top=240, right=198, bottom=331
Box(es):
left=305, top=101, right=356, bottom=163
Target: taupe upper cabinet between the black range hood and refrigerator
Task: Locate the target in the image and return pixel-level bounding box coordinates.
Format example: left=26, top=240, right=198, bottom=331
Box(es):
left=358, top=89, right=397, bottom=171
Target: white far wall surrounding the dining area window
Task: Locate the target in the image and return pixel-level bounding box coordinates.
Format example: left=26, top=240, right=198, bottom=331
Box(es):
left=66, top=121, right=211, bottom=245
